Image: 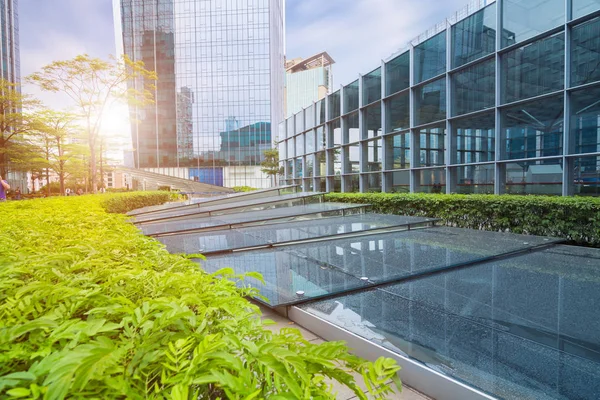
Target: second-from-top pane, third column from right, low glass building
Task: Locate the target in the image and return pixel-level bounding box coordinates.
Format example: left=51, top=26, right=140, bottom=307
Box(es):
left=452, top=59, right=496, bottom=115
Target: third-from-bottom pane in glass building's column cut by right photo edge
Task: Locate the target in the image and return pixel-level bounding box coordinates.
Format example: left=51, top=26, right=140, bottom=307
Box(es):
left=571, top=18, right=600, bottom=86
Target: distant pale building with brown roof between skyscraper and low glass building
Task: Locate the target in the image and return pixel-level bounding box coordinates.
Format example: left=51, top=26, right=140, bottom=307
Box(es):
left=285, top=52, right=335, bottom=118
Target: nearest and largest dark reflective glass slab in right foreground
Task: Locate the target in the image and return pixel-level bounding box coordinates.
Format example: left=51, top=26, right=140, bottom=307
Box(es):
left=301, top=246, right=600, bottom=400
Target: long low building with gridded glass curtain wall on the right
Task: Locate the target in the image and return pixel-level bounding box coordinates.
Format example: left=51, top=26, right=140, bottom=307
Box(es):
left=279, top=0, right=600, bottom=195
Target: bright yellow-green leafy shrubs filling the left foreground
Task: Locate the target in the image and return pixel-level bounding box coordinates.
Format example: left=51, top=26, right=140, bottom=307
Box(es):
left=0, top=192, right=398, bottom=399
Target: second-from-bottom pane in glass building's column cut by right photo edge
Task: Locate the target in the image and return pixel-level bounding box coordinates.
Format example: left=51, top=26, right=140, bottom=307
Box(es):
left=571, top=87, right=600, bottom=153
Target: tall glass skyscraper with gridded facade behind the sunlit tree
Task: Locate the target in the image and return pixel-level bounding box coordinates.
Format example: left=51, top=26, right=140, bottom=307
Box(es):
left=114, top=0, right=284, bottom=187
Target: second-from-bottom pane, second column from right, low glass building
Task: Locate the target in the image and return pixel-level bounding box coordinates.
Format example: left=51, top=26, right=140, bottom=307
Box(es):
left=502, top=95, right=564, bottom=160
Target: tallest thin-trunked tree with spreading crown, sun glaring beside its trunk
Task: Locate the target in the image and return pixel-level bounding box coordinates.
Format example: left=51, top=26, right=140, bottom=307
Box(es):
left=28, top=54, right=157, bottom=193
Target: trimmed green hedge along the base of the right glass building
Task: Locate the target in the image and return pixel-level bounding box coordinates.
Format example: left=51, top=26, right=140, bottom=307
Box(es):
left=326, top=193, right=600, bottom=247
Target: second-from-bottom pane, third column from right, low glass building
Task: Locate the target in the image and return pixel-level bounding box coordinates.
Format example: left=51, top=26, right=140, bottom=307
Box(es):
left=452, top=114, right=496, bottom=164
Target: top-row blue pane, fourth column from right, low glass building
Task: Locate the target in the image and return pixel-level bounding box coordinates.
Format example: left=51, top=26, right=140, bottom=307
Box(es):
left=414, top=31, right=446, bottom=83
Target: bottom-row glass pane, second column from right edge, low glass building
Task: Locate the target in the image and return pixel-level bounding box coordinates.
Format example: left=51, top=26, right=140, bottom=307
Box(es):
left=505, top=159, right=563, bottom=196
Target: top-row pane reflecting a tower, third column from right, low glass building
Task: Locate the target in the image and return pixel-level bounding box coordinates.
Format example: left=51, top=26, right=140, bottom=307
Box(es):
left=452, top=4, right=496, bottom=68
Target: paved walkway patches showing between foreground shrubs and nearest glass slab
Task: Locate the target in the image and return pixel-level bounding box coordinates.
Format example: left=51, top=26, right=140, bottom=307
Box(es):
left=259, top=306, right=431, bottom=400
